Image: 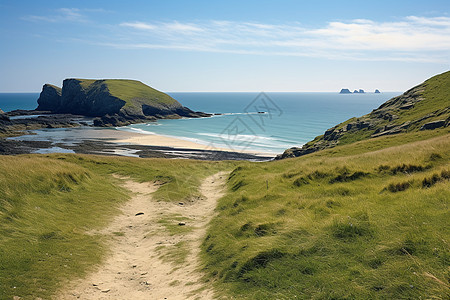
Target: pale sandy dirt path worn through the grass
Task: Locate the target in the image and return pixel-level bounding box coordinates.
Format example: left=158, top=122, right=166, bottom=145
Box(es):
left=57, top=173, right=229, bottom=300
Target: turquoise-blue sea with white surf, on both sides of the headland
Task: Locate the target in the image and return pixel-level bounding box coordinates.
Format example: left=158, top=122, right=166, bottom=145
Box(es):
left=0, top=92, right=400, bottom=154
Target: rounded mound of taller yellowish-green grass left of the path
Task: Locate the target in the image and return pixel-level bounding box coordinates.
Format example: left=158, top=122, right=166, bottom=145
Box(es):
left=0, top=157, right=128, bottom=299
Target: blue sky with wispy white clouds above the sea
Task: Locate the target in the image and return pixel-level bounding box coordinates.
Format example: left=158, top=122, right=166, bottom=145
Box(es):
left=0, top=0, right=450, bottom=92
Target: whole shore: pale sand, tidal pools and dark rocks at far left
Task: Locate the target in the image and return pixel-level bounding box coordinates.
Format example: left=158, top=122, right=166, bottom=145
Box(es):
left=0, top=110, right=276, bottom=161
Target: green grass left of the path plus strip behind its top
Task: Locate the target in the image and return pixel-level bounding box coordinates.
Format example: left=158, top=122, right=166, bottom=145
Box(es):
left=0, top=155, right=232, bottom=299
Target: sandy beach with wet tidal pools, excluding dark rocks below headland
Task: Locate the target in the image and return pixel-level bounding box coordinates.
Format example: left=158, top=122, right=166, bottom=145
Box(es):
left=0, top=126, right=275, bottom=161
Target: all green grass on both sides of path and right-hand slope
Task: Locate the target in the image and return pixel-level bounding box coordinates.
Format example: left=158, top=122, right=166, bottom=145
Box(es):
left=0, top=72, right=450, bottom=299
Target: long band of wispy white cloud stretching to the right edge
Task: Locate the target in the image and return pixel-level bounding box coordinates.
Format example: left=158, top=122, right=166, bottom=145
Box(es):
left=109, top=16, right=450, bottom=62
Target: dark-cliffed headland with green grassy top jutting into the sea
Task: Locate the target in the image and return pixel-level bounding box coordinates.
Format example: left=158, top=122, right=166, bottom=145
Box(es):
left=37, top=79, right=210, bottom=126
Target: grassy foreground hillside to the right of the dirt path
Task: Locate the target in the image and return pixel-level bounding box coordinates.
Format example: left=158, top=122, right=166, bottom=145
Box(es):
left=203, top=134, right=450, bottom=299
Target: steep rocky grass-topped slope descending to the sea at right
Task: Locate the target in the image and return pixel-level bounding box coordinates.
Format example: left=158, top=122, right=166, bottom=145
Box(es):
left=277, top=71, right=450, bottom=159
